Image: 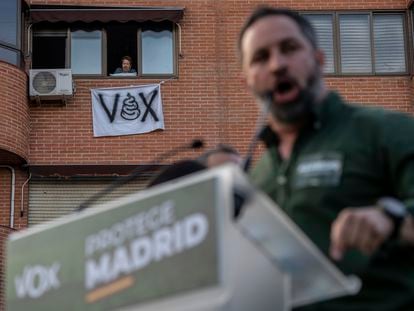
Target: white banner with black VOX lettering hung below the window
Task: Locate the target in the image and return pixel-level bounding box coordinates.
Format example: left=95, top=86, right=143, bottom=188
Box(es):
left=91, top=84, right=164, bottom=137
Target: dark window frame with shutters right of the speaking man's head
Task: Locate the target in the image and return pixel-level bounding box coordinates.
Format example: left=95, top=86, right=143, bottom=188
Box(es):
left=300, top=10, right=414, bottom=77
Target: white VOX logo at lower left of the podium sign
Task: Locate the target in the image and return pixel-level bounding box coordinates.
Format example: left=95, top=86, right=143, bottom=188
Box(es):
left=14, top=262, right=60, bottom=298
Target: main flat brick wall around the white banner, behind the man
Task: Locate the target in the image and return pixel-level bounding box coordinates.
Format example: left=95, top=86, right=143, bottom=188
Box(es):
left=30, top=0, right=412, bottom=164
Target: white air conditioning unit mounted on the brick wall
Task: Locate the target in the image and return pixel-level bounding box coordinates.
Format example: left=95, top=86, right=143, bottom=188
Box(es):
left=29, top=69, right=73, bottom=99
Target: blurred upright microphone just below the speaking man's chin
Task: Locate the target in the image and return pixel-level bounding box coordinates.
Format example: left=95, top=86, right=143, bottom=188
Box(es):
left=242, top=91, right=273, bottom=172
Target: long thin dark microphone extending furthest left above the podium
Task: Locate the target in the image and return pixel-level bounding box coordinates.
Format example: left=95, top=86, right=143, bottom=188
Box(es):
left=76, top=139, right=204, bottom=212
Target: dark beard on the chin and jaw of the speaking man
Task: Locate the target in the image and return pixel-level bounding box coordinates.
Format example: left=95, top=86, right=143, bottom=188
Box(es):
left=261, top=72, right=320, bottom=124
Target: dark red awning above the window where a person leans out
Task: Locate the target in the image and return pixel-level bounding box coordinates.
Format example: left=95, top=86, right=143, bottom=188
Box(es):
left=29, top=5, right=184, bottom=23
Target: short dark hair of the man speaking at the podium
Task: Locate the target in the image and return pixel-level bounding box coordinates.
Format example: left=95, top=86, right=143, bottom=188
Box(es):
left=237, top=6, right=318, bottom=56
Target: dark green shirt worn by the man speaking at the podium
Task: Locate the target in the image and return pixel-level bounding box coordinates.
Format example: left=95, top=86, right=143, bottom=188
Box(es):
left=251, top=92, right=414, bottom=311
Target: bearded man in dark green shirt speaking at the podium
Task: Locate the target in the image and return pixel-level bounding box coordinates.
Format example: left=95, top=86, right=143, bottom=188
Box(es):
left=239, top=8, right=414, bottom=311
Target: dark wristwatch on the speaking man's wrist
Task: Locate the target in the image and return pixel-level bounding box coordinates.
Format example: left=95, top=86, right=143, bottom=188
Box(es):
left=377, top=197, right=407, bottom=239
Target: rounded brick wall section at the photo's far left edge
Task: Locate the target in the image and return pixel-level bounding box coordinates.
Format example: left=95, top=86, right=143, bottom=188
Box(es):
left=0, top=61, right=30, bottom=310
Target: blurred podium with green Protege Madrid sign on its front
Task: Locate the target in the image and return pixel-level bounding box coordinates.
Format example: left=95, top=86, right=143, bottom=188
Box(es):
left=6, top=165, right=360, bottom=311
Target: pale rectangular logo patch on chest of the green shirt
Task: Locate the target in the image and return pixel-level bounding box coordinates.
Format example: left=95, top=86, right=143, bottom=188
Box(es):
left=293, top=151, right=343, bottom=188
